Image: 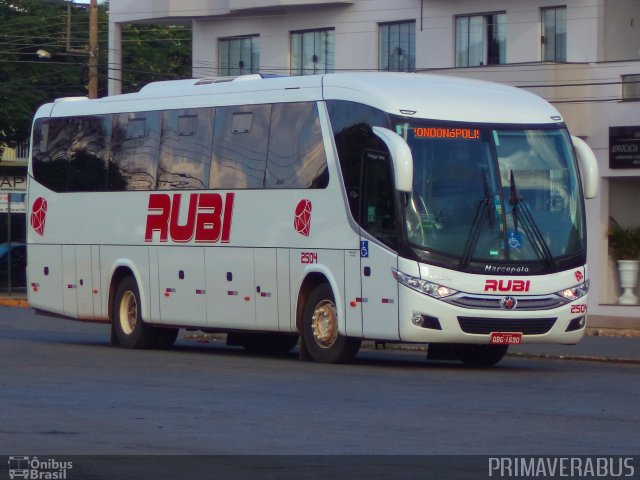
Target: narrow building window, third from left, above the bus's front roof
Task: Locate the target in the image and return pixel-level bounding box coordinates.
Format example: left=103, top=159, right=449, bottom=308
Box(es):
left=378, top=21, right=416, bottom=72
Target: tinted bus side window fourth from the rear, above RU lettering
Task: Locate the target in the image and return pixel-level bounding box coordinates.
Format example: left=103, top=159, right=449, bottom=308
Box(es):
left=158, top=108, right=215, bottom=190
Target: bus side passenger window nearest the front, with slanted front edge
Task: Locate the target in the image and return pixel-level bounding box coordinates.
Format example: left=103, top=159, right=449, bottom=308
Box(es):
left=265, top=102, right=329, bottom=188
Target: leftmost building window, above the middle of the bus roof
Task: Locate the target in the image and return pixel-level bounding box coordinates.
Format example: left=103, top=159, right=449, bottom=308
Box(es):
left=218, top=35, right=260, bottom=76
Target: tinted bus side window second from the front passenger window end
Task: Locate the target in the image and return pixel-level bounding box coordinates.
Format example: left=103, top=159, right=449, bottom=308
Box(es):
left=209, top=105, right=271, bottom=188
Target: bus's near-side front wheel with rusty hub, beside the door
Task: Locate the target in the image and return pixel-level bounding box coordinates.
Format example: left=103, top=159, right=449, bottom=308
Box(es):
left=302, top=283, right=362, bottom=363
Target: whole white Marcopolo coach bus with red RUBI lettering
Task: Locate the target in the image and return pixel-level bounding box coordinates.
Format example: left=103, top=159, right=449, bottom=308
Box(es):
left=28, top=73, right=598, bottom=365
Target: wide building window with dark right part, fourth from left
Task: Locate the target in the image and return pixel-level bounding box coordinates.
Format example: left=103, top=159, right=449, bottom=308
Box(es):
left=456, top=13, right=507, bottom=67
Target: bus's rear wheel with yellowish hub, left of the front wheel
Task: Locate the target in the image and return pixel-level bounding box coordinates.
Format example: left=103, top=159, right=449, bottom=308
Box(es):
left=111, top=277, right=158, bottom=348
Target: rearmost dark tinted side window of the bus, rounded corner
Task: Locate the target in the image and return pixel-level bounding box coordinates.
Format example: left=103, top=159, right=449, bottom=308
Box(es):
left=33, top=118, right=71, bottom=192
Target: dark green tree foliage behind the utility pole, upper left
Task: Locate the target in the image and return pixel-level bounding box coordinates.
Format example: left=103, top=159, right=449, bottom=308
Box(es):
left=0, top=0, right=191, bottom=153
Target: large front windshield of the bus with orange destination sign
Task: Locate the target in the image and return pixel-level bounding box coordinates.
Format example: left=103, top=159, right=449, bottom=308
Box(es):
left=396, top=121, right=585, bottom=269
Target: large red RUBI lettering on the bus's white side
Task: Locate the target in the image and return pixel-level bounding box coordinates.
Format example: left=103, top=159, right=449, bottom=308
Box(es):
left=144, top=193, right=234, bottom=243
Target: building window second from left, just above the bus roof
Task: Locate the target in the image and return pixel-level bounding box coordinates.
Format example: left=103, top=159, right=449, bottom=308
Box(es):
left=291, top=29, right=335, bottom=75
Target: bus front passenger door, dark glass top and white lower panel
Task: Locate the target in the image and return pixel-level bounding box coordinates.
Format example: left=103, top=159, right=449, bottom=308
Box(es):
left=360, top=150, right=400, bottom=340
